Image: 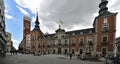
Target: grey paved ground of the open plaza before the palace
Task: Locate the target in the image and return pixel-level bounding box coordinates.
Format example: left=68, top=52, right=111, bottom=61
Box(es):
left=0, top=54, right=104, bottom=64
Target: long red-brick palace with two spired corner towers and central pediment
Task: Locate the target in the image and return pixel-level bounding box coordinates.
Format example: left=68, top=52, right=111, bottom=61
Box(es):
left=19, top=0, right=117, bottom=55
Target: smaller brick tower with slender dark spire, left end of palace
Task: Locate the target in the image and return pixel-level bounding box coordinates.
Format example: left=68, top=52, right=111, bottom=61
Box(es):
left=31, top=13, right=43, bottom=52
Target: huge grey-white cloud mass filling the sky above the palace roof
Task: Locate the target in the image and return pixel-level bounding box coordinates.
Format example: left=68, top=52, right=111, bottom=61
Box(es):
left=15, top=0, right=120, bottom=36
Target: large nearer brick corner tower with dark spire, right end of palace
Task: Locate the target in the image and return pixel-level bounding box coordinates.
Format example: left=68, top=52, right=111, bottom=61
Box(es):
left=93, top=0, right=117, bottom=55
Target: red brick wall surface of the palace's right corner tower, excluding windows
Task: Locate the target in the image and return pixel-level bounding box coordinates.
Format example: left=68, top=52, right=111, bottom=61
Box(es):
left=96, top=15, right=116, bottom=51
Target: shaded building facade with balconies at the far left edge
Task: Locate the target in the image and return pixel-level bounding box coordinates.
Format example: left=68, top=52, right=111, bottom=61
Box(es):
left=0, top=0, right=7, bottom=55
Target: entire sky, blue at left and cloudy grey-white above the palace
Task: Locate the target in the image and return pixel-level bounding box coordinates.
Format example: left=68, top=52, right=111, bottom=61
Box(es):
left=4, top=0, right=120, bottom=48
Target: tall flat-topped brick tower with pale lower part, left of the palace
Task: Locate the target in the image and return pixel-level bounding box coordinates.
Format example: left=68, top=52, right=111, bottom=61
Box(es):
left=18, top=16, right=31, bottom=52
